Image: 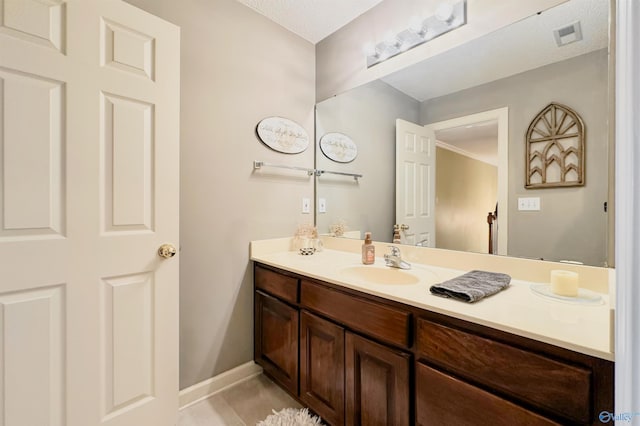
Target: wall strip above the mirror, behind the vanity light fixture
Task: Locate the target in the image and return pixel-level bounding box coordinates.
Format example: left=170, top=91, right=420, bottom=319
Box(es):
left=316, top=0, right=566, bottom=101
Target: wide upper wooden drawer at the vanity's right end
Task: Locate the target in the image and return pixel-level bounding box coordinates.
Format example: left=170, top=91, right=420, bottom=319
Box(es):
left=417, top=319, right=592, bottom=423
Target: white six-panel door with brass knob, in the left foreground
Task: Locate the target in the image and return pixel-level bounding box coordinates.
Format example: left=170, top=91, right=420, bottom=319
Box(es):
left=0, top=0, right=179, bottom=426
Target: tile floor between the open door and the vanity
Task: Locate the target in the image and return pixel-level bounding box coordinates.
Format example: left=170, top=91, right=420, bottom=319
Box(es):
left=177, top=374, right=301, bottom=426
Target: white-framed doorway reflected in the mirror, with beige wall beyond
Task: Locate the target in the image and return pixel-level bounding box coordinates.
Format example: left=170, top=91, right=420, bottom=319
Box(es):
left=425, top=107, right=509, bottom=255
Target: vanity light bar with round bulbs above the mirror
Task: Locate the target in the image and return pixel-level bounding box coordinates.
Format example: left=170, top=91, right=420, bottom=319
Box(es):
left=363, top=0, right=467, bottom=68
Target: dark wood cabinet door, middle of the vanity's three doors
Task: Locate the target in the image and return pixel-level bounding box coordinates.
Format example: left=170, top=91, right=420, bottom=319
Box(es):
left=300, top=310, right=344, bottom=425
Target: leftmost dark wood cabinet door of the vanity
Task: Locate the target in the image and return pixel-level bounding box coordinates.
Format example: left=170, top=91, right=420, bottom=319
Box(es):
left=254, top=292, right=299, bottom=395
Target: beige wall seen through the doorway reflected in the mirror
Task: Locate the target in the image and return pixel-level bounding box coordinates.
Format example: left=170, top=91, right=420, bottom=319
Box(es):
left=436, top=147, right=498, bottom=253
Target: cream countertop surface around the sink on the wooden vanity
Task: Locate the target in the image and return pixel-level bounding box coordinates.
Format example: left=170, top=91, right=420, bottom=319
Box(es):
left=251, top=249, right=614, bottom=361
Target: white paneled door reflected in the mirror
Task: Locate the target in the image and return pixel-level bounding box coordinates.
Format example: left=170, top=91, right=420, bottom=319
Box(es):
left=396, top=119, right=436, bottom=247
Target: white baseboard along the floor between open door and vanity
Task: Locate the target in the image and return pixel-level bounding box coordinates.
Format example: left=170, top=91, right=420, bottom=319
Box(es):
left=178, top=361, right=262, bottom=410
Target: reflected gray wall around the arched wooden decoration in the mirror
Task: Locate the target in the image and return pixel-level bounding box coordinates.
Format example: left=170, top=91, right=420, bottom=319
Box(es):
left=421, top=49, right=609, bottom=266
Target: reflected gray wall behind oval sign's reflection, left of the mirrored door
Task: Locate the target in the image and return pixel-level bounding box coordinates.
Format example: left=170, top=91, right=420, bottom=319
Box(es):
left=316, top=81, right=420, bottom=241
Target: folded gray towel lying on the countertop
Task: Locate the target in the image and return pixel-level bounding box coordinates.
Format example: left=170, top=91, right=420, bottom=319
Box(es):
left=429, top=271, right=511, bottom=303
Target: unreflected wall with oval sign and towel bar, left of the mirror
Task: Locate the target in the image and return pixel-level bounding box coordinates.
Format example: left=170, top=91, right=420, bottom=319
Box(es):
left=123, top=0, right=315, bottom=388
